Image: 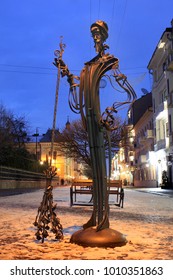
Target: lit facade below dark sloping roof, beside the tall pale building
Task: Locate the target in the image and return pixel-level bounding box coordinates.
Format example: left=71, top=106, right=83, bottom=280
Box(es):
left=133, top=99, right=157, bottom=187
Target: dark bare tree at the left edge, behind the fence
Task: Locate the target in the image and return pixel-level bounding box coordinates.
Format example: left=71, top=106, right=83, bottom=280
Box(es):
left=0, top=104, right=36, bottom=170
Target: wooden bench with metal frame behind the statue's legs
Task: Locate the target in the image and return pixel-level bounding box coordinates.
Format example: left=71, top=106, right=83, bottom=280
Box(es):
left=70, top=180, right=124, bottom=208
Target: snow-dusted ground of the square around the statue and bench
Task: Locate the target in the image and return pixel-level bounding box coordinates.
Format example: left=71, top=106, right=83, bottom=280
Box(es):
left=0, top=186, right=173, bottom=260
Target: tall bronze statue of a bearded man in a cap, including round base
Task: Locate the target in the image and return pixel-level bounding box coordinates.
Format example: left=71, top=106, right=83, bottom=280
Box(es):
left=54, top=21, right=136, bottom=247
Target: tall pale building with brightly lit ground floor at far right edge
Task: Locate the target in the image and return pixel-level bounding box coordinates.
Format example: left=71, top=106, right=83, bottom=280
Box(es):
left=148, top=20, right=173, bottom=187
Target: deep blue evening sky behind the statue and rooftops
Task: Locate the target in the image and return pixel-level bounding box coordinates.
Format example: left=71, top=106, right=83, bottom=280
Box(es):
left=0, top=0, right=173, bottom=134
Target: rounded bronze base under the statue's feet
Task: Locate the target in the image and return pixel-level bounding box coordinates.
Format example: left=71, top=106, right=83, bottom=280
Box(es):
left=70, top=227, right=127, bottom=248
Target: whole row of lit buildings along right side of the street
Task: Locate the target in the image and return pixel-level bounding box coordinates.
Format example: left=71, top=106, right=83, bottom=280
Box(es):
left=113, top=20, right=173, bottom=188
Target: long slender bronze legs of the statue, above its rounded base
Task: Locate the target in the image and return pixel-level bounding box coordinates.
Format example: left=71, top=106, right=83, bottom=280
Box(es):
left=83, top=106, right=109, bottom=230
